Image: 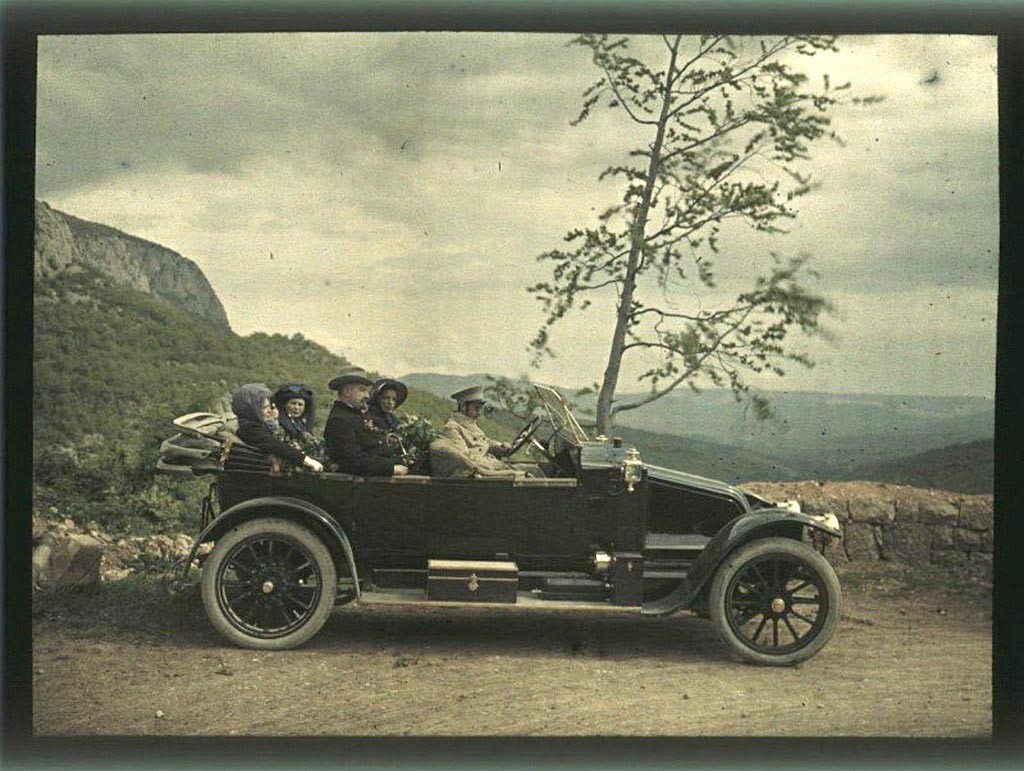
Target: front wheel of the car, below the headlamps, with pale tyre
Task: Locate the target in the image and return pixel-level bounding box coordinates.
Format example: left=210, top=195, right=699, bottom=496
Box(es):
left=709, top=538, right=843, bottom=667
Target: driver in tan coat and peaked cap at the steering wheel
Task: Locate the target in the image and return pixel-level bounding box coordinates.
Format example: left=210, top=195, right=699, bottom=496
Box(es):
left=430, top=386, right=544, bottom=476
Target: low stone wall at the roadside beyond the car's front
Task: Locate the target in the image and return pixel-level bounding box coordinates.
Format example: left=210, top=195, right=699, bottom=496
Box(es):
left=741, top=482, right=992, bottom=582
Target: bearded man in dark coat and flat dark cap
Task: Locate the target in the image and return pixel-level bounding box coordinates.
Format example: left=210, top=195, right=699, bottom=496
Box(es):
left=324, top=367, right=409, bottom=476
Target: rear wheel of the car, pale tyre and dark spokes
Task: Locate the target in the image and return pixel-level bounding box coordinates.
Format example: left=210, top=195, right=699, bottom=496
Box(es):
left=201, top=519, right=338, bottom=650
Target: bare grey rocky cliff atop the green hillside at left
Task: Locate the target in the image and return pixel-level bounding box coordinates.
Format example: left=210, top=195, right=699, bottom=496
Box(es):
left=35, top=201, right=230, bottom=330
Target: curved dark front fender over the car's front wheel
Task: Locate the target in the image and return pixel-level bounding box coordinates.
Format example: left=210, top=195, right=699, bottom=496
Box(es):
left=642, top=508, right=843, bottom=615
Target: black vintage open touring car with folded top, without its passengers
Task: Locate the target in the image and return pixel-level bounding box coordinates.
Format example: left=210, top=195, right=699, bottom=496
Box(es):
left=158, top=386, right=842, bottom=665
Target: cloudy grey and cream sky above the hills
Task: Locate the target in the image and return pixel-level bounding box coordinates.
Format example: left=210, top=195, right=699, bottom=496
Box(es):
left=37, top=33, right=998, bottom=396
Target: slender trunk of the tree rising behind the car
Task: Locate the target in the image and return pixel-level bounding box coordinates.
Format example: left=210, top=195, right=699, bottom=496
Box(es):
left=597, top=38, right=679, bottom=436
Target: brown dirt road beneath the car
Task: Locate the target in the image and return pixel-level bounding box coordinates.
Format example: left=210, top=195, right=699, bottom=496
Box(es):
left=33, top=575, right=991, bottom=736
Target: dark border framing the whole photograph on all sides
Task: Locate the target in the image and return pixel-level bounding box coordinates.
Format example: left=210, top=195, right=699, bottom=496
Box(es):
left=0, top=0, right=1024, bottom=768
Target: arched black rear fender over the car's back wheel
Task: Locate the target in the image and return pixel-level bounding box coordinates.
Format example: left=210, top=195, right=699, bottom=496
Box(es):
left=185, top=496, right=359, bottom=599
